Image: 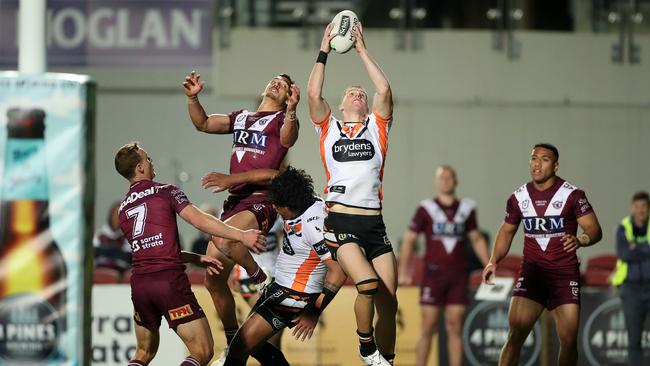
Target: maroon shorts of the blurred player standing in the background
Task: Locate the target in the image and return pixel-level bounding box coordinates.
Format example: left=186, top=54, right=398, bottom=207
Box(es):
left=420, top=264, right=469, bottom=306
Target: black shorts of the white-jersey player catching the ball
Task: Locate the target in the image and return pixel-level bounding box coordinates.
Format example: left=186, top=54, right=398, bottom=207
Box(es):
left=323, top=212, right=393, bottom=260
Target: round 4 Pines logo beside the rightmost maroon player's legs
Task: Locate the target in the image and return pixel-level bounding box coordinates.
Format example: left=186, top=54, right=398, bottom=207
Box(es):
left=463, top=302, right=542, bottom=366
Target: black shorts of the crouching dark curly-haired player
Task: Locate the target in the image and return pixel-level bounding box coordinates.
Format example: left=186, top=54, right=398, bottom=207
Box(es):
left=252, top=282, right=318, bottom=332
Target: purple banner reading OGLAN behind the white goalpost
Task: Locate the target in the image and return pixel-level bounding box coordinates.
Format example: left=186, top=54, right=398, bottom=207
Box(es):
left=0, top=0, right=214, bottom=68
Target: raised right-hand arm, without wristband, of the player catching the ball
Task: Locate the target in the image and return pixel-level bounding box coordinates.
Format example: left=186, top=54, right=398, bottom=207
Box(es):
left=352, top=22, right=393, bottom=119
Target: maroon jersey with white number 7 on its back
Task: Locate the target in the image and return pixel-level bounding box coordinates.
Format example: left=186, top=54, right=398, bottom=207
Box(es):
left=119, top=180, right=190, bottom=274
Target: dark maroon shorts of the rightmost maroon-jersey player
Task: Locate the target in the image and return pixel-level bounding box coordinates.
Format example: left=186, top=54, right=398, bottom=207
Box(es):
left=512, top=261, right=580, bottom=310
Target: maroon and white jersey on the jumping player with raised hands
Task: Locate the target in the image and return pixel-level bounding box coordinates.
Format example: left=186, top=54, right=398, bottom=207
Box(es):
left=228, top=110, right=288, bottom=194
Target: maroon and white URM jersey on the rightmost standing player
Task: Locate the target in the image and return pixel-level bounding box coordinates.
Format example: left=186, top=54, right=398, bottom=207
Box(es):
left=505, top=177, right=593, bottom=268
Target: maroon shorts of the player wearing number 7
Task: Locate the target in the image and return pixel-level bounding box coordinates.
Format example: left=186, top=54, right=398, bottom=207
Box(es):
left=131, top=270, right=205, bottom=331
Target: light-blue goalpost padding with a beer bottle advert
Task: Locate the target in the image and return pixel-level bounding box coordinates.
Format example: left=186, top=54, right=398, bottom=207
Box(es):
left=0, top=72, right=94, bottom=365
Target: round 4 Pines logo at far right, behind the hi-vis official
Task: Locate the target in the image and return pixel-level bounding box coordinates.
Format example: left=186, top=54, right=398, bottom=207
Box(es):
left=581, top=298, right=650, bottom=366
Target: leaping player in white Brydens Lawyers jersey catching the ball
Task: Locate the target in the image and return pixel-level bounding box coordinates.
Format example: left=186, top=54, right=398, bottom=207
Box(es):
left=307, top=17, right=397, bottom=365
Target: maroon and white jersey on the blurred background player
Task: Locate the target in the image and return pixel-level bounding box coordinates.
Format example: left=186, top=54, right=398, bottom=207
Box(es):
left=409, top=198, right=478, bottom=269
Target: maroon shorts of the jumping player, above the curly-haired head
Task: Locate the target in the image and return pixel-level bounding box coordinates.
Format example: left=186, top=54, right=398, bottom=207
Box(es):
left=221, top=194, right=278, bottom=233
